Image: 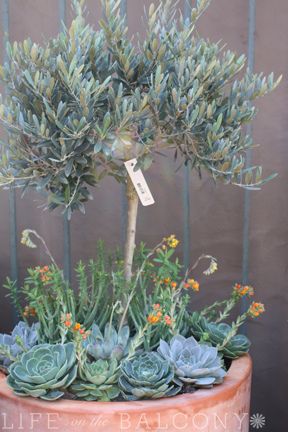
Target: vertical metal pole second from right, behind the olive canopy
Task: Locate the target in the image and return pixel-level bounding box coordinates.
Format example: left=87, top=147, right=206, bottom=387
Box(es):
left=183, top=0, right=191, bottom=270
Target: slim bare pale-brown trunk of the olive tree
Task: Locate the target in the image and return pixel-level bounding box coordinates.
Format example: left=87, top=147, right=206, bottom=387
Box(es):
left=124, top=177, right=139, bottom=282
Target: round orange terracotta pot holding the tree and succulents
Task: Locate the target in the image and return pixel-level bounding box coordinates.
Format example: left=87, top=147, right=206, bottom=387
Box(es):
left=0, top=355, right=252, bottom=432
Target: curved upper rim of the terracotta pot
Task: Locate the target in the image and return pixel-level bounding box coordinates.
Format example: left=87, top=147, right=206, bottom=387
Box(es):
left=0, top=354, right=252, bottom=415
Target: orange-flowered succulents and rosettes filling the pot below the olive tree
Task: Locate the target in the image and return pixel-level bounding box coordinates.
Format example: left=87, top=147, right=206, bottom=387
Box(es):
left=0, top=231, right=264, bottom=402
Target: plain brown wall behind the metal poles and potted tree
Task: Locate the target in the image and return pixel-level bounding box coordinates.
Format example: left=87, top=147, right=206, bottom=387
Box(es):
left=0, top=0, right=288, bottom=432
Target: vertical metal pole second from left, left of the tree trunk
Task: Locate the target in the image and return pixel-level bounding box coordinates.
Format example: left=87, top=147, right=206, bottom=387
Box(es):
left=59, top=0, right=72, bottom=282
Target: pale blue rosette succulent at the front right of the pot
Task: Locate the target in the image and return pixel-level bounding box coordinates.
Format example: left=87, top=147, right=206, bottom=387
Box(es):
left=158, top=335, right=226, bottom=387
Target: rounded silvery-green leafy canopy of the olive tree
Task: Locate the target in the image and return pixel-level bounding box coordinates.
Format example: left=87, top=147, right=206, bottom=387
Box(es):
left=0, top=0, right=279, bottom=216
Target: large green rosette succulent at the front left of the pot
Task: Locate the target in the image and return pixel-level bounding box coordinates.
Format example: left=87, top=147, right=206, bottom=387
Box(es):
left=7, top=342, right=77, bottom=401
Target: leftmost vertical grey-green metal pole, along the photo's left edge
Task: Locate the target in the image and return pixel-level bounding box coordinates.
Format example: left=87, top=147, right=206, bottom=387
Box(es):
left=1, top=0, right=18, bottom=324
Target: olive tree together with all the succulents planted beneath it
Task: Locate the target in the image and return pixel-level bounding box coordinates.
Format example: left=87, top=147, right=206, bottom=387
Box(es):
left=0, top=0, right=274, bottom=401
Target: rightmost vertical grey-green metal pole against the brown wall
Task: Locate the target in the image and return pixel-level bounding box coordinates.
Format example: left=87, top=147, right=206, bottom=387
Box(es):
left=242, top=0, right=256, bottom=320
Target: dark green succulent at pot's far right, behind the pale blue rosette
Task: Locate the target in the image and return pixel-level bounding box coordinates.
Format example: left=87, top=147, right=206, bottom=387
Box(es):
left=190, top=312, right=251, bottom=359
